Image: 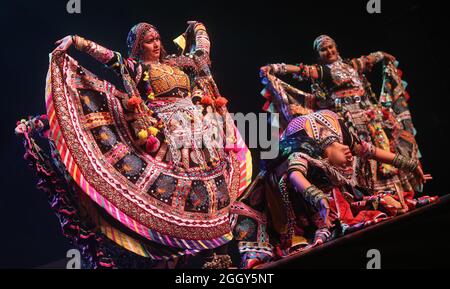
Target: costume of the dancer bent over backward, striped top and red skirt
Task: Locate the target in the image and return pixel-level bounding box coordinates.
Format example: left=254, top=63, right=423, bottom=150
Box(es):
left=229, top=110, right=436, bottom=267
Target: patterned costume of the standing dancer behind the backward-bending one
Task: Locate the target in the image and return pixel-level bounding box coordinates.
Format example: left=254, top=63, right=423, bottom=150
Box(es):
left=263, top=52, right=420, bottom=193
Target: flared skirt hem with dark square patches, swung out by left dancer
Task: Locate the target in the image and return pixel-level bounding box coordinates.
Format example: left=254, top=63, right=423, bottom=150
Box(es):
left=47, top=51, right=239, bottom=249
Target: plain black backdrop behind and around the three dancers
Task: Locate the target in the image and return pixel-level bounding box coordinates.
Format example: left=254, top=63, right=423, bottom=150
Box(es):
left=0, top=0, right=450, bottom=268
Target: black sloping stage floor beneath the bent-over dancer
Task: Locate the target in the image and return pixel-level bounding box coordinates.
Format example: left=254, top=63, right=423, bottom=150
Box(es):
left=257, top=194, right=450, bottom=269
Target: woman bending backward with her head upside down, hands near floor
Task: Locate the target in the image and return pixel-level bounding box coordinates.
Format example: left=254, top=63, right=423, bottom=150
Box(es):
left=232, top=110, right=437, bottom=268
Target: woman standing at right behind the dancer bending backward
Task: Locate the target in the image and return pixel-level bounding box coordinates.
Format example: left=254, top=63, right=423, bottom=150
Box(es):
left=261, top=35, right=421, bottom=199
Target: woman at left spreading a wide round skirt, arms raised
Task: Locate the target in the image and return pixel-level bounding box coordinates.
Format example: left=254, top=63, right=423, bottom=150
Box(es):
left=16, top=22, right=251, bottom=267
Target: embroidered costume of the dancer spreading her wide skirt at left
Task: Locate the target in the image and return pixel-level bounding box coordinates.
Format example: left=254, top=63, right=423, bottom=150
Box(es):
left=38, top=25, right=251, bottom=258
